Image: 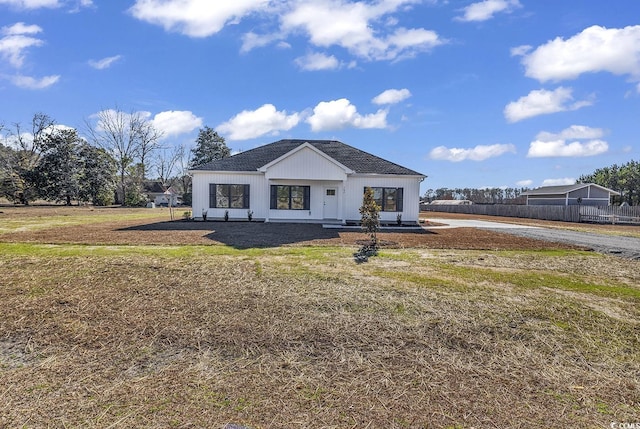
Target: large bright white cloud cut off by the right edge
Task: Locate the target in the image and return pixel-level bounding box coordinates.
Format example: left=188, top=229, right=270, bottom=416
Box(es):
left=522, top=25, right=640, bottom=82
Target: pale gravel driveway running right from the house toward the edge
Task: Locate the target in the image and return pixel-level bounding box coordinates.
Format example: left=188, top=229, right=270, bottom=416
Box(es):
left=430, top=218, right=640, bottom=260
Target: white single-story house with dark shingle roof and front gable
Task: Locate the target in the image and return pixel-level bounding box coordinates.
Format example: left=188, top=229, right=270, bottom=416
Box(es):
left=190, top=140, right=426, bottom=224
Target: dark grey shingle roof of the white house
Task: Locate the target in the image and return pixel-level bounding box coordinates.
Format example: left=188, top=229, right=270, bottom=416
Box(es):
left=192, top=140, right=424, bottom=176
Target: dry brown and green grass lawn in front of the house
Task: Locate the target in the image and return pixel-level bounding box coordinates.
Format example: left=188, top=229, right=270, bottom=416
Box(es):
left=0, top=209, right=640, bottom=429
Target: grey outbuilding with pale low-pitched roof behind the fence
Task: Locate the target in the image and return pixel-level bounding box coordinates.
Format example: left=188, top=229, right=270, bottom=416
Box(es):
left=520, top=183, right=620, bottom=206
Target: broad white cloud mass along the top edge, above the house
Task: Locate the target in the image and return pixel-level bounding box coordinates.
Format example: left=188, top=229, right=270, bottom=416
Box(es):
left=129, top=0, right=447, bottom=61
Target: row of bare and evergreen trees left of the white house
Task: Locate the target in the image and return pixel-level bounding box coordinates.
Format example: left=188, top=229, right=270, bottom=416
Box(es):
left=0, top=108, right=231, bottom=206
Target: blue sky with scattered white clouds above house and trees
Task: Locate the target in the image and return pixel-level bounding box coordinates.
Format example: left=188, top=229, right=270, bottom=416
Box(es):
left=0, top=0, right=640, bottom=193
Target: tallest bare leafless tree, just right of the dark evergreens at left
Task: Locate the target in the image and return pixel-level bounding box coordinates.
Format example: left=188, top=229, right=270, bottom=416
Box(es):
left=85, top=106, right=161, bottom=204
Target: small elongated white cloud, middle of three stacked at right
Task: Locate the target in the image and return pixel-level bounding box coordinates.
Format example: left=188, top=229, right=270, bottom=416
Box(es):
left=504, top=86, right=593, bottom=122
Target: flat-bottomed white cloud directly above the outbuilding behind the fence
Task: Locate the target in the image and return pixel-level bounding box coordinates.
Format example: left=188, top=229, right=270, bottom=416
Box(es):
left=527, top=125, right=609, bottom=158
